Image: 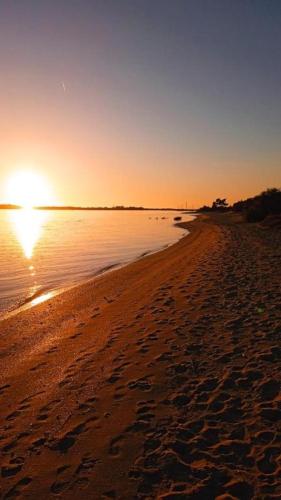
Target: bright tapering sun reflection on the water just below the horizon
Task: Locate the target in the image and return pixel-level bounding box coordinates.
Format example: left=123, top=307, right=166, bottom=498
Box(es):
left=9, top=208, right=48, bottom=260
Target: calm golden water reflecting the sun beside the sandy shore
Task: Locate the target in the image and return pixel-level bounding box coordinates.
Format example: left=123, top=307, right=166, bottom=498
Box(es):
left=0, top=210, right=193, bottom=317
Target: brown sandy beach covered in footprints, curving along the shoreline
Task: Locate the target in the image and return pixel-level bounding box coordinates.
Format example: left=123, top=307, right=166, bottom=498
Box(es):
left=0, top=214, right=281, bottom=500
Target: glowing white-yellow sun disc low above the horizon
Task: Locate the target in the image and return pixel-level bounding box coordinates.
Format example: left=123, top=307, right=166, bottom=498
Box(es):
left=6, top=170, right=52, bottom=208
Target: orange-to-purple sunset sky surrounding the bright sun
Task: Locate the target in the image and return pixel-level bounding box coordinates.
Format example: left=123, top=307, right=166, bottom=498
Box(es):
left=0, top=0, right=281, bottom=207
